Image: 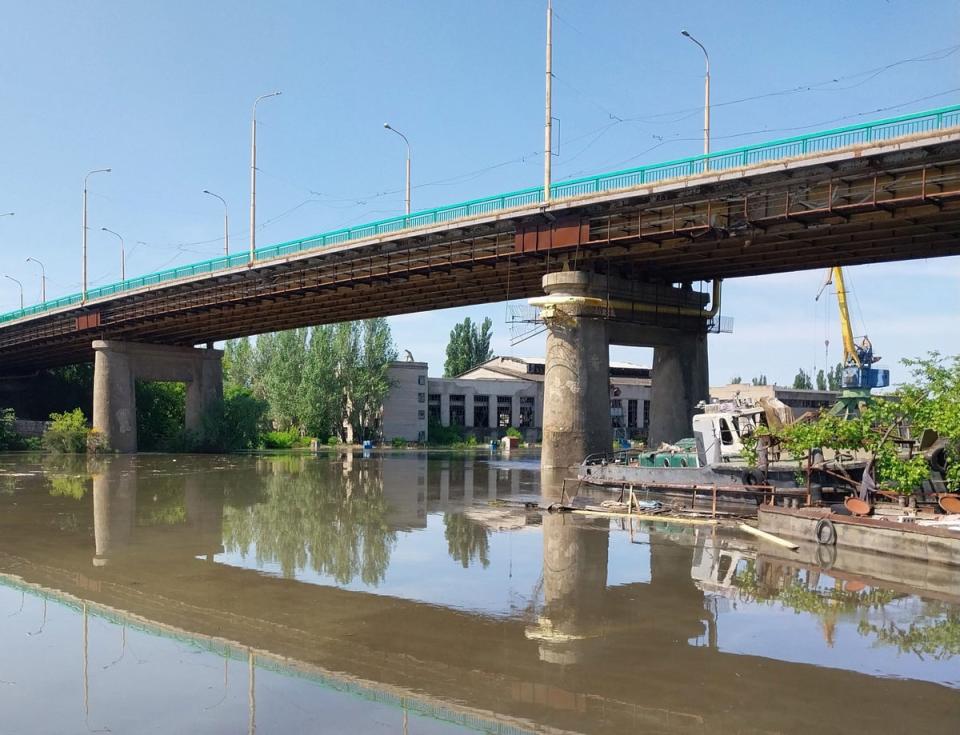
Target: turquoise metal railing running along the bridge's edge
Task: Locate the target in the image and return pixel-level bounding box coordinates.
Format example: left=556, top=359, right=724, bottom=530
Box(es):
left=0, top=105, right=960, bottom=324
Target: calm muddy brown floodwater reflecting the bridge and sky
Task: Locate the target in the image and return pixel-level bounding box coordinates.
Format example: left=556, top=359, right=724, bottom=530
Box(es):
left=0, top=452, right=960, bottom=735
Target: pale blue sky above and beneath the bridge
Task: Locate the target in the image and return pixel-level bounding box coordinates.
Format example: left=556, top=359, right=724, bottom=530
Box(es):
left=0, top=0, right=960, bottom=383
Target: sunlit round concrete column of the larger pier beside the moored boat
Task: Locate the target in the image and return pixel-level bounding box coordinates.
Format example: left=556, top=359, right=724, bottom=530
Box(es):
left=540, top=272, right=613, bottom=469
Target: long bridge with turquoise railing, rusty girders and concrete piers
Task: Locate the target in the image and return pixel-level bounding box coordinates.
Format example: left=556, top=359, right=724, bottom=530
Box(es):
left=0, top=105, right=960, bottom=458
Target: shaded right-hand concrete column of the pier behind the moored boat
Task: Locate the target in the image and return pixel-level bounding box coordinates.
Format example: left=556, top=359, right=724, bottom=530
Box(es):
left=641, top=332, right=710, bottom=446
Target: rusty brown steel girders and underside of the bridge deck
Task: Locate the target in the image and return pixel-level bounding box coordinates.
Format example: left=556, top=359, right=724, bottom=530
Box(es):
left=0, top=140, right=960, bottom=374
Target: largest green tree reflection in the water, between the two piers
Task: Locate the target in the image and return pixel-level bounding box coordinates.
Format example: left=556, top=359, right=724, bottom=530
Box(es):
left=223, top=457, right=396, bottom=585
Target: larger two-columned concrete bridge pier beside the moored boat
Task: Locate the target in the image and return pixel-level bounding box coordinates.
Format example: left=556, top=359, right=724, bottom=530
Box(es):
left=540, top=271, right=716, bottom=472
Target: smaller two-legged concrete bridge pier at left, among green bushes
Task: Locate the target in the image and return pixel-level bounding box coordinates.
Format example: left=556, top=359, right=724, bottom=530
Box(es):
left=93, top=340, right=223, bottom=452
